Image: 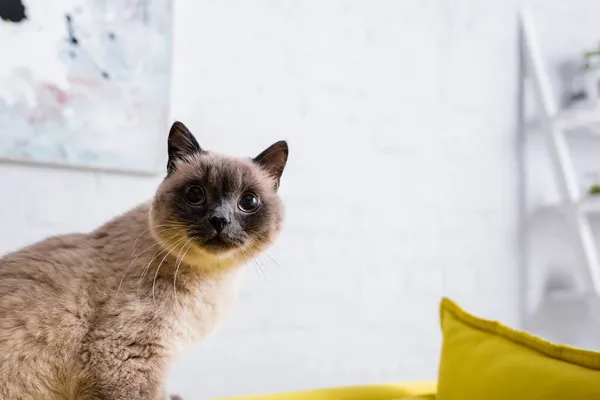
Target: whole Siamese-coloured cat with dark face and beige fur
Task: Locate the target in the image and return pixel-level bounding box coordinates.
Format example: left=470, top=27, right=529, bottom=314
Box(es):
left=0, top=122, right=288, bottom=400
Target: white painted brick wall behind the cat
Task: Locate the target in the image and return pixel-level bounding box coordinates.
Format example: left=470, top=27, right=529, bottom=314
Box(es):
left=0, top=0, right=600, bottom=399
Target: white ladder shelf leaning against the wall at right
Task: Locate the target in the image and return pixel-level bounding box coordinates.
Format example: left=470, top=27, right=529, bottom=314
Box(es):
left=520, top=10, right=600, bottom=311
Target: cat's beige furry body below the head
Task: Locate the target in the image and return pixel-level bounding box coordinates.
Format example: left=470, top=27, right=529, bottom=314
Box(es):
left=0, top=206, right=238, bottom=399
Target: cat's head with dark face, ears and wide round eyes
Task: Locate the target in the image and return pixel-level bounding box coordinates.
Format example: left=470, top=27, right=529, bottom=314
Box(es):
left=151, top=122, right=288, bottom=264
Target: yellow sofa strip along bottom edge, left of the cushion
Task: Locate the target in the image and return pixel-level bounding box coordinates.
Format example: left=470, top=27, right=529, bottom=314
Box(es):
left=216, top=382, right=436, bottom=400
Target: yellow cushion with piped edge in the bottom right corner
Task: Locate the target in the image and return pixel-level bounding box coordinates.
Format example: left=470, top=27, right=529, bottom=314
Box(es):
left=436, top=299, right=600, bottom=400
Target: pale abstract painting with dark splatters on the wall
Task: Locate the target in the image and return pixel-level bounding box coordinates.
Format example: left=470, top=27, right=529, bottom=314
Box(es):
left=0, top=0, right=173, bottom=173
